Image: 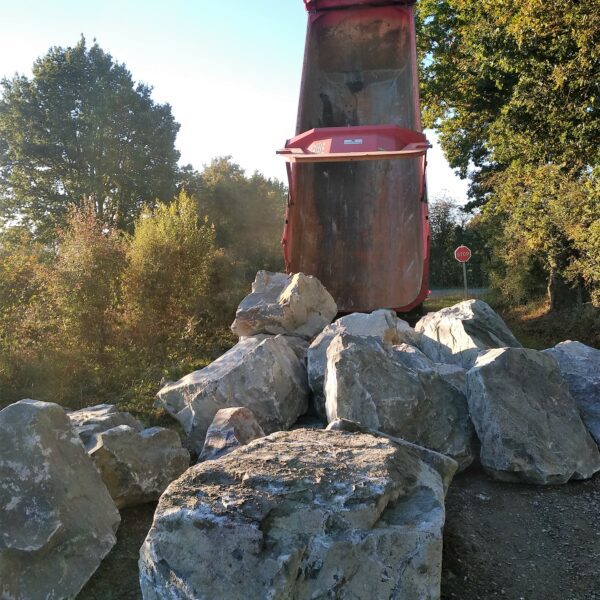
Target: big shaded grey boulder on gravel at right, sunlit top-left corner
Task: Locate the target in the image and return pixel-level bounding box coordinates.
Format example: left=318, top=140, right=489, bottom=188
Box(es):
left=467, top=348, right=600, bottom=484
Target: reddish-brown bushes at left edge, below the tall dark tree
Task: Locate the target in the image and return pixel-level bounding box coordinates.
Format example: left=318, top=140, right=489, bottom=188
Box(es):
left=0, top=204, right=125, bottom=407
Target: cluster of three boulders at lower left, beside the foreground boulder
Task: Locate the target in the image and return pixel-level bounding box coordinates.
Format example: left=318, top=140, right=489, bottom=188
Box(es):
left=0, top=400, right=190, bottom=600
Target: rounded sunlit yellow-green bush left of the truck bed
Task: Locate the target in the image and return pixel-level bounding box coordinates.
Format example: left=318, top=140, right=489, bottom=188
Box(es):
left=123, top=192, right=218, bottom=362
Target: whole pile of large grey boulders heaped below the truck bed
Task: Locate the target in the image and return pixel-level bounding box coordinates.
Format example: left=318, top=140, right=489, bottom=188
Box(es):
left=0, top=272, right=600, bottom=600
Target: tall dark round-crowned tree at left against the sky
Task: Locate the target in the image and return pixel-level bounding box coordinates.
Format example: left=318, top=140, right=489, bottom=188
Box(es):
left=0, top=38, right=179, bottom=235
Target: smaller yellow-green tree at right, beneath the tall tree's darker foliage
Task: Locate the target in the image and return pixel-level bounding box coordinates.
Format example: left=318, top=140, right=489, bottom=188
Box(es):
left=482, top=164, right=600, bottom=309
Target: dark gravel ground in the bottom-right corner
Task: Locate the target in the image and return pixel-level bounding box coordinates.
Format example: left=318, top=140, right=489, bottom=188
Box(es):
left=442, top=470, right=600, bottom=600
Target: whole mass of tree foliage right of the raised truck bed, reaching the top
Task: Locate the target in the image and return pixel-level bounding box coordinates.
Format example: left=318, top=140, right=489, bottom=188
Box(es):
left=417, top=0, right=600, bottom=307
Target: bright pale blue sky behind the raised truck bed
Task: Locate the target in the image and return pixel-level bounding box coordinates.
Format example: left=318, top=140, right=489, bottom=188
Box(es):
left=0, top=0, right=466, bottom=201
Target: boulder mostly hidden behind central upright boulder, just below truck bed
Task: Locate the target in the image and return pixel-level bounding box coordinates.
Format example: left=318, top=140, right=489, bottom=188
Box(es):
left=308, top=310, right=418, bottom=419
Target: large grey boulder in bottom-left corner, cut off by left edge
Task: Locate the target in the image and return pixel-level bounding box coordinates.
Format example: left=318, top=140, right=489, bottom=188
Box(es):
left=0, top=400, right=121, bottom=600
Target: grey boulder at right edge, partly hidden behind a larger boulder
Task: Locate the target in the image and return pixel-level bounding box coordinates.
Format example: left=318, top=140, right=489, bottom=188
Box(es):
left=544, top=340, right=600, bottom=446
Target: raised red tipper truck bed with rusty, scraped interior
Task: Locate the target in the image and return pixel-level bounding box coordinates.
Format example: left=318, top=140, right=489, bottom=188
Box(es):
left=279, top=0, right=429, bottom=312
